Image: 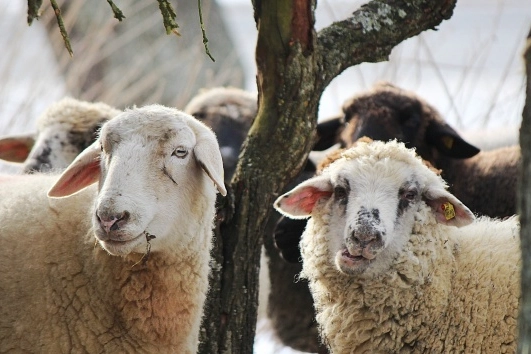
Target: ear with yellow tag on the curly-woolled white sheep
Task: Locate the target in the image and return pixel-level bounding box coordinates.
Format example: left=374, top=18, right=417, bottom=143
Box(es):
left=424, top=188, right=476, bottom=227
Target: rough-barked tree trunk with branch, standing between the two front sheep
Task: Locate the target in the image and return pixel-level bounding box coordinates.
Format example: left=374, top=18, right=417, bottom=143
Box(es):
left=199, top=0, right=455, bottom=354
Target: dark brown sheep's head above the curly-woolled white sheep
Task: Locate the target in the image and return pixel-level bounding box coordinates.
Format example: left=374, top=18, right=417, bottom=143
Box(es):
left=341, top=82, right=479, bottom=162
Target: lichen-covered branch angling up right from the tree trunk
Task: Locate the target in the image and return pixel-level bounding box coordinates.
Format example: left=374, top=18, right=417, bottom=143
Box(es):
left=317, top=0, right=456, bottom=80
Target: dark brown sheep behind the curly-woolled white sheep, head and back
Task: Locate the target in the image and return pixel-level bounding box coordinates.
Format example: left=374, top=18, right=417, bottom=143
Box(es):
left=342, top=83, right=521, bottom=217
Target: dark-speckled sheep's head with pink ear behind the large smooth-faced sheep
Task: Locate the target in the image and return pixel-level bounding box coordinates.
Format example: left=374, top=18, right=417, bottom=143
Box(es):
left=0, top=97, right=121, bottom=173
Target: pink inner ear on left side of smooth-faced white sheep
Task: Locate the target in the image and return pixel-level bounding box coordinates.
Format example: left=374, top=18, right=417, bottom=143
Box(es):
left=48, top=140, right=101, bottom=198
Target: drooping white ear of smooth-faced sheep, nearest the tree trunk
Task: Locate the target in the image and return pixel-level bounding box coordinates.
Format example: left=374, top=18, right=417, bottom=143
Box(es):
left=194, top=133, right=227, bottom=196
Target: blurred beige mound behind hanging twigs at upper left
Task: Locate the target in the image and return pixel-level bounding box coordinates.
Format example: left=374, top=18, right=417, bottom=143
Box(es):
left=41, top=0, right=243, bottom=107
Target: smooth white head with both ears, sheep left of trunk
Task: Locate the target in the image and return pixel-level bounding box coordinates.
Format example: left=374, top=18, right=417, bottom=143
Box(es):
left=49, top=105, right=226, bottom=255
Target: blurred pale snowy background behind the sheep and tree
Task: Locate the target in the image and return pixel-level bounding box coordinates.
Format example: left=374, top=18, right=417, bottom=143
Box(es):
left=0, top=0, right=531, bottom=353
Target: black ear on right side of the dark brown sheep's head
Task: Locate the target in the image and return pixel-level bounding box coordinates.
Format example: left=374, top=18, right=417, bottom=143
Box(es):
left=426, top=121, right=479, bottom=159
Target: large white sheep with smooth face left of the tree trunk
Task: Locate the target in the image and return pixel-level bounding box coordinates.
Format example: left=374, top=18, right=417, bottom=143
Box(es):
left=0, top=105, right=226, bottom=353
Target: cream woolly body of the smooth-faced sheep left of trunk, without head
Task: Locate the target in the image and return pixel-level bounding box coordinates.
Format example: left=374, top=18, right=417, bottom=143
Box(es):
left=0, top=169, right=214, bottom=354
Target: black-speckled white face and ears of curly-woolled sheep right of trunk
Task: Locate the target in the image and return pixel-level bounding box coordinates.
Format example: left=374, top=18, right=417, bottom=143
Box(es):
left=275, top=142, right=474, bottom=277
